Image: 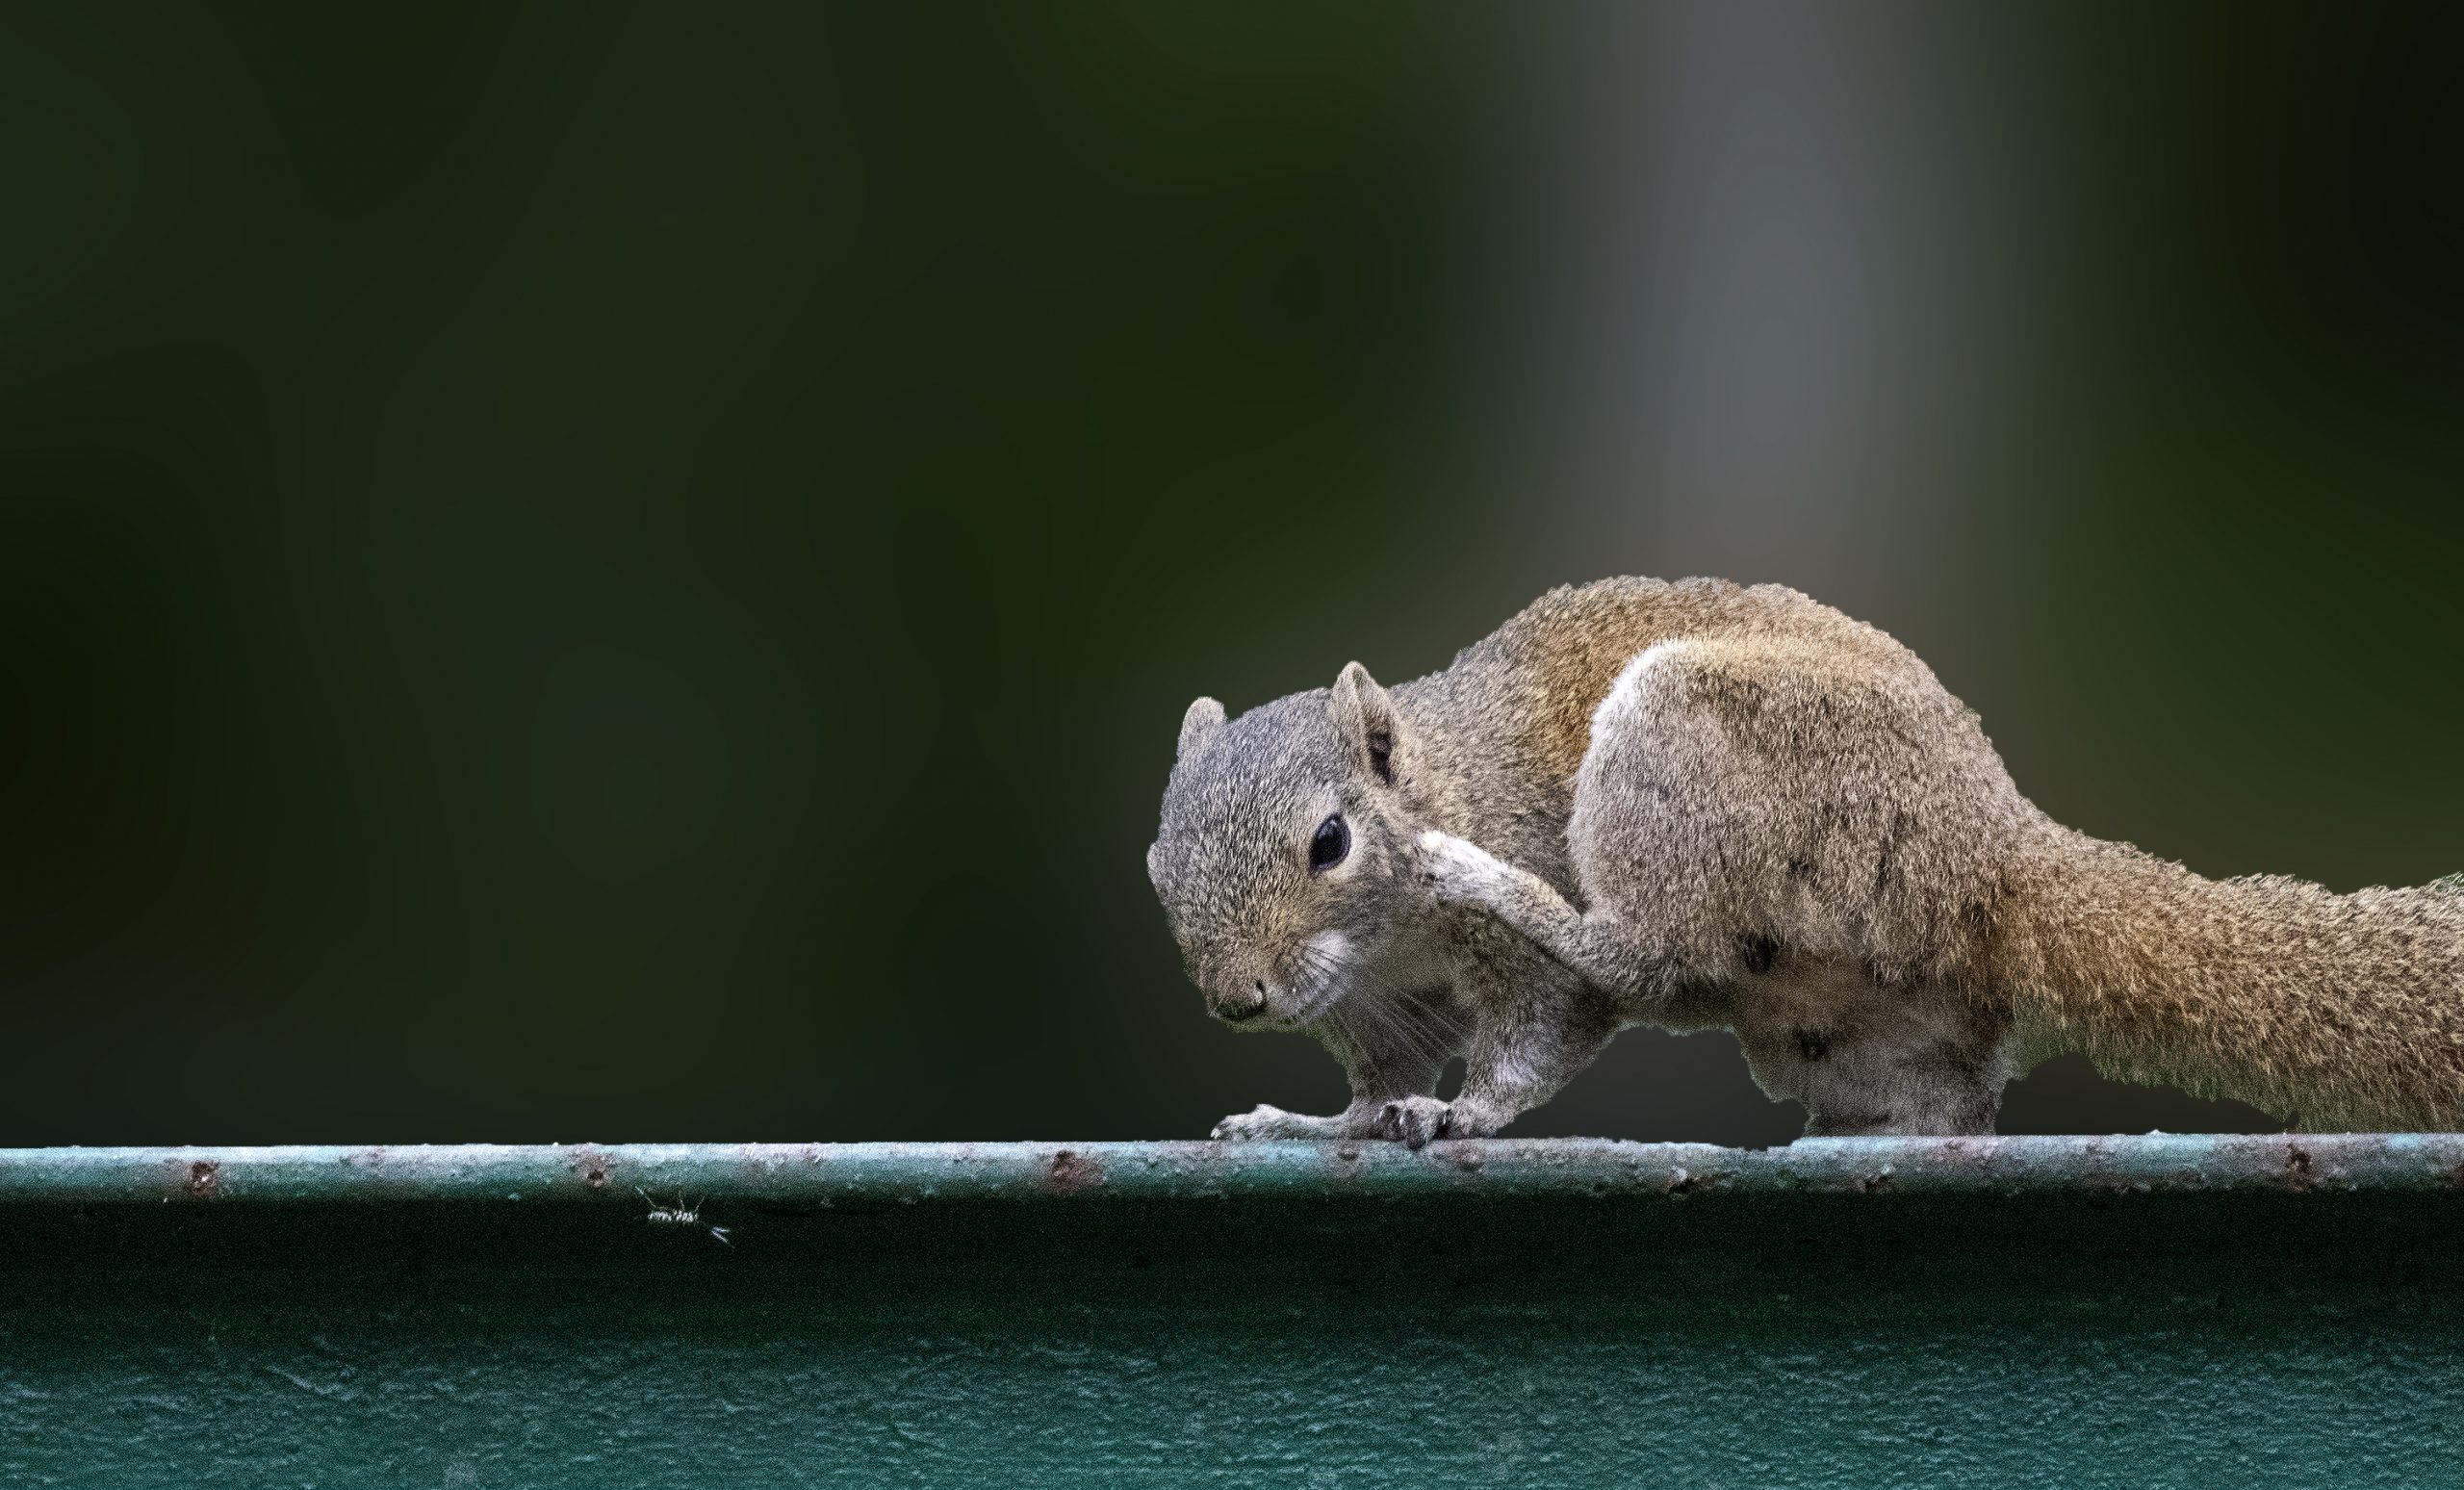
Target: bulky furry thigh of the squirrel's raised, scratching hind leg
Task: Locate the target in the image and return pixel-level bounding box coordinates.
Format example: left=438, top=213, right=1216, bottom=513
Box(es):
left=1567, top=628, right=2038, bottom=985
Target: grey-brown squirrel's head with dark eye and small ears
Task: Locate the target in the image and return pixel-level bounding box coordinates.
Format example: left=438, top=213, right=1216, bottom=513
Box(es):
left=1145, top=662, right=1420, bottom=1030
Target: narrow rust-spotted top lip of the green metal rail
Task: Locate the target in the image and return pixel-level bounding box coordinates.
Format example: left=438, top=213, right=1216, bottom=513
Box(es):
left=0, top=1133, right=2464, bottom=1204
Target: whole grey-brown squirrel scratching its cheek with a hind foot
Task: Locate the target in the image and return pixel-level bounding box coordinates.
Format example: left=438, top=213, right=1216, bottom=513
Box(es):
left=1145, top=578, right=2464, bottom=1147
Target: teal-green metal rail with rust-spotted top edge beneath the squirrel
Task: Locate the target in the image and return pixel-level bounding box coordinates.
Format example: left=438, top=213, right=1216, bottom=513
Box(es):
left=0, top=1136, right=2464, bottom=1487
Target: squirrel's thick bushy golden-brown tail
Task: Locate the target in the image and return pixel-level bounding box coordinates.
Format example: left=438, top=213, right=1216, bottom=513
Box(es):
left=1989, top=830, right=2464, bottom=1130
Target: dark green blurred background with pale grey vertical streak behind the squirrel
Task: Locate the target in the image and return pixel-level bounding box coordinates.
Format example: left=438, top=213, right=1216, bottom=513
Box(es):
left=0, top=3, right=2464, bottom=1143
